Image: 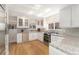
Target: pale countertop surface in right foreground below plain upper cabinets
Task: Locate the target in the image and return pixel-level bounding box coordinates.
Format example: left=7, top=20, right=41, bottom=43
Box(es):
left=51, top=33, right=79, bottom=55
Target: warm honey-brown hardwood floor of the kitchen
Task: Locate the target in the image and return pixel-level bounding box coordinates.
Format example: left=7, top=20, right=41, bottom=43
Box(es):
left=10, top=40, right=49, bottom=55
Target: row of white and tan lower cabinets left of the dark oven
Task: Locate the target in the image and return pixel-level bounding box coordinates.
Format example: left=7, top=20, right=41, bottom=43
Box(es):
left=17, top=31, right=44, bottom=43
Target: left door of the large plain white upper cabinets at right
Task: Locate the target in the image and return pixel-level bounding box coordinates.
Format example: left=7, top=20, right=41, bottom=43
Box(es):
left=60, top=6, right=71, bottom=28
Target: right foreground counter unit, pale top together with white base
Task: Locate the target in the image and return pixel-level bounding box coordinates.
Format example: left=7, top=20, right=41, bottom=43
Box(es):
left=49, top=33, right=79, bottom=55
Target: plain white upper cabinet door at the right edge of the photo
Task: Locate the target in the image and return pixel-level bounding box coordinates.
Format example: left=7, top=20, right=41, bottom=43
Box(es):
left=72, top=5, right=79, bottom=27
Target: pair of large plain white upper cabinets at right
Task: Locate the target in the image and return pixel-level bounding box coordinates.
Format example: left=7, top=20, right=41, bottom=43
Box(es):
left=60, top=5, right=79, bottom=28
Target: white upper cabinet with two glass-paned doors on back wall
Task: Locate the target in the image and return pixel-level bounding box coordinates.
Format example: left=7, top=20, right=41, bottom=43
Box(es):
left=17, top=17, right=28, bottom=28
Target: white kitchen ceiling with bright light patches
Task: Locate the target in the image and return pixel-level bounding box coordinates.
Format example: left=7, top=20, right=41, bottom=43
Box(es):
left=8, top=4, right=68, bottom=17
